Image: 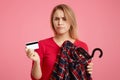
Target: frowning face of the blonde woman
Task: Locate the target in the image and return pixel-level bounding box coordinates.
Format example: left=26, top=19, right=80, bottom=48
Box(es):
left=53, top=9, right=70, bottom=35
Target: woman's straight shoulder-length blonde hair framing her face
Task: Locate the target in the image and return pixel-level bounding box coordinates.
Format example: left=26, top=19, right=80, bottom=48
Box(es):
left=50, top=4, right=78, bottom=39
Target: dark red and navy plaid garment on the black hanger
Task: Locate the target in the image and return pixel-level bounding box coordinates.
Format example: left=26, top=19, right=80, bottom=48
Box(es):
left=50, top=41, right=92, bottom=80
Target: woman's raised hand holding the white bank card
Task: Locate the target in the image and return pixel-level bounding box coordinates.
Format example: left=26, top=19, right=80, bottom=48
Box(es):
left=25, top=48, right=40, bottom=62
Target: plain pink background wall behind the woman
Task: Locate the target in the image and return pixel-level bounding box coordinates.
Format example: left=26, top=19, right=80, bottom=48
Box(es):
left=0, top=0, right=120, bottom=80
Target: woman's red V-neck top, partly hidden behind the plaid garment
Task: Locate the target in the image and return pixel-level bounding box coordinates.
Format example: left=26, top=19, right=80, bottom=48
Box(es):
left=32, top=37, right=88, bottom=80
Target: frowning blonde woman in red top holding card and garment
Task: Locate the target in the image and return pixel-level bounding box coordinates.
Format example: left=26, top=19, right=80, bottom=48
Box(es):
left=26, top=4, right=92, bottom=80
